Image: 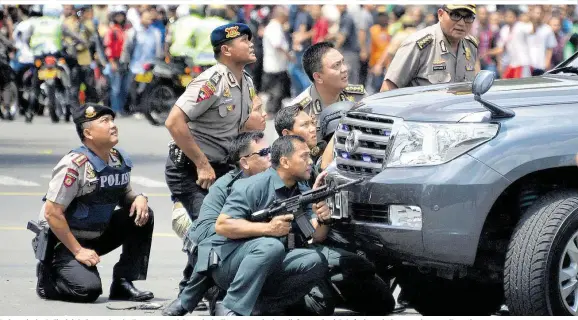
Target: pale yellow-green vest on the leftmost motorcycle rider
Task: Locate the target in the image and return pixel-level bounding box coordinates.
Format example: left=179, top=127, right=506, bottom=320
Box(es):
left=30, top=17, right=62, bottom=56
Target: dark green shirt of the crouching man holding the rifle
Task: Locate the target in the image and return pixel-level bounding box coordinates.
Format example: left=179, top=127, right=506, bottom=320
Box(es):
left=195, top=168, right=315, bottom=272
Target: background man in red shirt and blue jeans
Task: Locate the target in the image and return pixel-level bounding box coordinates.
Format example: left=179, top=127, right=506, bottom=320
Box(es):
left=104, top=5, right=127, bottom=114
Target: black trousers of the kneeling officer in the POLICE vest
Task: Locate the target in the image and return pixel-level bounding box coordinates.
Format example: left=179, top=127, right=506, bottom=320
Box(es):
left=42, top=208, right=154, bottom=302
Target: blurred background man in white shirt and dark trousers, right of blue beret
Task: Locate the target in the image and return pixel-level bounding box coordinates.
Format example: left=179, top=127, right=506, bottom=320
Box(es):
left=263, top=6, right=292, bottom=115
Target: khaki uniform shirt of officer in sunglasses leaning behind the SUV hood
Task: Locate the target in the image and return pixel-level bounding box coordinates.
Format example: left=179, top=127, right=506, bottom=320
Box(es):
left=384, top=23, right=478, bottom=88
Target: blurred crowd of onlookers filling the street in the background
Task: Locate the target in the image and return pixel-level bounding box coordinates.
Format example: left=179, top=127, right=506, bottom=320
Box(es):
left=0, top=5, right=578, bottom=119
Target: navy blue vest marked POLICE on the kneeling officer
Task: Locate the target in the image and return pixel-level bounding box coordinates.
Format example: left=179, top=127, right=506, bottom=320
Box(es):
left=65, top=146, right=132, bottom=231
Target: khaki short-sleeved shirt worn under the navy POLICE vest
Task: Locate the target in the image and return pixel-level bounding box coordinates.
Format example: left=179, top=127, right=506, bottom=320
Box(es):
left=38, top=152, right=132, bottom=221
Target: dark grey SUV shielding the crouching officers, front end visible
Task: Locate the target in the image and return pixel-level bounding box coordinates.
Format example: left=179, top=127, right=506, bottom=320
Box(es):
left=328, top=54, right=578, bottom=315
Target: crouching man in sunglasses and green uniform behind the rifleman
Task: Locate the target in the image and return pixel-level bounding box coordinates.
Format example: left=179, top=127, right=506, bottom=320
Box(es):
left=163, top=131, right=271, bottom=316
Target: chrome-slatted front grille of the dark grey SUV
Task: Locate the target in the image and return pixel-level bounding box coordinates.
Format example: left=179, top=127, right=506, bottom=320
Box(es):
left=334, top=112, right=393, bottom=175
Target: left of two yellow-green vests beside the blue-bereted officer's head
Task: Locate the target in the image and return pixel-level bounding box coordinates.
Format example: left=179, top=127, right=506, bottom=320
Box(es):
left=170, top=15, right=203, bottom=58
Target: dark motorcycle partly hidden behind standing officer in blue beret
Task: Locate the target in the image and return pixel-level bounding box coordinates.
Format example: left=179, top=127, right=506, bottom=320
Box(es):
left=135, top=57, right=211, bottom=126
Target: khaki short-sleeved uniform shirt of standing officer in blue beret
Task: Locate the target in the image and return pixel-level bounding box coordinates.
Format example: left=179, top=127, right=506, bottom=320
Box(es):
left=175, top=63, right=256, bottom=163
